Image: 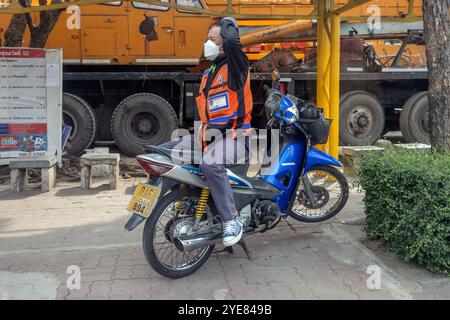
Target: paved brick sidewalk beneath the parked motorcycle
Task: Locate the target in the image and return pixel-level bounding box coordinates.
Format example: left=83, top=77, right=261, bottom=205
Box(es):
left=0, top=180, right=450, bottom=299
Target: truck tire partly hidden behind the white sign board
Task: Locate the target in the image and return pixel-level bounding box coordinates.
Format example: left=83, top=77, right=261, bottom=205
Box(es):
left=63, top=92, right=97, bottom=156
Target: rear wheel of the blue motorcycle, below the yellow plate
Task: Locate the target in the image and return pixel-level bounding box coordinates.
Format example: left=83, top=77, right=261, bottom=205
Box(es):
left=143, top=189, right=214, bottom=279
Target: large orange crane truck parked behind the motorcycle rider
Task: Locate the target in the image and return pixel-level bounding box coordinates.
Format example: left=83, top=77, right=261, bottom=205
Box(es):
left=0, top=0, right=428, bottom=155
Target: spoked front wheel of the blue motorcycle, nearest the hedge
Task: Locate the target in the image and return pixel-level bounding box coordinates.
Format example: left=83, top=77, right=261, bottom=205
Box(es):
left=289, top=165, right=349, bottom=222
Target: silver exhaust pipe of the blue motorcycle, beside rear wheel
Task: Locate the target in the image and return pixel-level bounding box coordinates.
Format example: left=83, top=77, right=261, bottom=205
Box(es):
left=174, top=229, right=257, bottom=252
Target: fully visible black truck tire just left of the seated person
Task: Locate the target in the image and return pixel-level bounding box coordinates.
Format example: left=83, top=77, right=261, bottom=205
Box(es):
left=111, top=93, right=178, bottom=156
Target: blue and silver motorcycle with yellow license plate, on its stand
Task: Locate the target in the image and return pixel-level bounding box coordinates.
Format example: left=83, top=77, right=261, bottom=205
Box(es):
left=125, top=77, right=349, bottom=278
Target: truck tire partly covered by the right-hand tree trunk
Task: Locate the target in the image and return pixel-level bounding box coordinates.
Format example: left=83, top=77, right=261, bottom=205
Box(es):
left=400, top=91, right=430, bottom=144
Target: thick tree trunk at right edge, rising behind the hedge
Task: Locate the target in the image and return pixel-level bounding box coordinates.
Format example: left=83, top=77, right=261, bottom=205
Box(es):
left=423, top=0, right=450, bottom=152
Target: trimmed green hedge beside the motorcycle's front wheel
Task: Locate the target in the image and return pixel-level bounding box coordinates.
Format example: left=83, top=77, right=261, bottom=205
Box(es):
left=356, top=148, right=450, bottom=274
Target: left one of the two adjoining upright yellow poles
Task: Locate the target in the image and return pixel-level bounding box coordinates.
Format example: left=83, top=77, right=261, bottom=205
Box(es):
left=316, top=0, right=331, bottom=152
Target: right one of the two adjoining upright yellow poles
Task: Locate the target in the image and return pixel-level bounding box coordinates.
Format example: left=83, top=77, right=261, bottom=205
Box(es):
left=328, top=14, right=341, bottom=159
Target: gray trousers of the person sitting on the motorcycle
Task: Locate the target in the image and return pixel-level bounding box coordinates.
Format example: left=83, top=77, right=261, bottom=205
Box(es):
left=160, top=135, right=248, bottom=222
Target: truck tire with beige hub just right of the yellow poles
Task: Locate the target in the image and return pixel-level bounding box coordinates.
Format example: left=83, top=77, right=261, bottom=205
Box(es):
left=339, top=91, right=385, bottom=146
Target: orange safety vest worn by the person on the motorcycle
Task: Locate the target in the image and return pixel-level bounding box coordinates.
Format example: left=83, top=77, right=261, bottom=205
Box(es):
left=196, top=64, right=253, bottom=150
